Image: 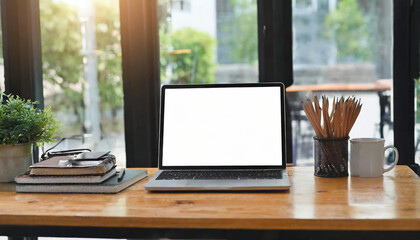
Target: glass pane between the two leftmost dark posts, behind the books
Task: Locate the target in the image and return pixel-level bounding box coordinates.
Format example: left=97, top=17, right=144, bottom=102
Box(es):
left=40, top=0, right=125, bottom=166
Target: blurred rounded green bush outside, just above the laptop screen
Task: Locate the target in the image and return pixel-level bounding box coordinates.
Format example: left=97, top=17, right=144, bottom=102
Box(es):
left=160, top=28, right=216, bottom=84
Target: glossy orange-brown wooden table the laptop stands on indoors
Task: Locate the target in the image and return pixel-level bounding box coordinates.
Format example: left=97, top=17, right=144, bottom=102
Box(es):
left=0, top=166, right=420, bottom=238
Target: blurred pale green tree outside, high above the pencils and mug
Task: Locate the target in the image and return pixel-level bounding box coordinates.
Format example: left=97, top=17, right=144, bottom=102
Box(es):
left=324, top=0, right=373, bottom=61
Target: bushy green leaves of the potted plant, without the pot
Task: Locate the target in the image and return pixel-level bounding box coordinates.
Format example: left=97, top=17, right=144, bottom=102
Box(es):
left=0, top=93, right=61, bottom=146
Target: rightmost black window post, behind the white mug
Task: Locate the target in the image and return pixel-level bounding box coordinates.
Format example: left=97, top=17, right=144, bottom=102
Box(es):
left=393, top=0, right=420, bottom=167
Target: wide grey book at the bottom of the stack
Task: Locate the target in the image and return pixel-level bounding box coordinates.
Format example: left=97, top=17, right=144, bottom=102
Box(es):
left=16, top=169, right=148, bottom=193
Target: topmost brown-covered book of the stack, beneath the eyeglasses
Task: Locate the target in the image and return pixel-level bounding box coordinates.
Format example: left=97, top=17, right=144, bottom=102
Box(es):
left=29, top=155, right=116, bottom=175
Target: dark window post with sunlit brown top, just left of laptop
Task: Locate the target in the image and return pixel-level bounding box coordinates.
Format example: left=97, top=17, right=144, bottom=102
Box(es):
left=120, top=0, right=160, bottom=167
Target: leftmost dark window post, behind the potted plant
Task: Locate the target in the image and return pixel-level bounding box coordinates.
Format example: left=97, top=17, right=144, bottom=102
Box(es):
left=0, top=0, right=44, bottom=162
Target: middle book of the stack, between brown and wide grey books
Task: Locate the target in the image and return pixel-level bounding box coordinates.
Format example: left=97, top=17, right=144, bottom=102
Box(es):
left=15, top=167, right=117, bottom=184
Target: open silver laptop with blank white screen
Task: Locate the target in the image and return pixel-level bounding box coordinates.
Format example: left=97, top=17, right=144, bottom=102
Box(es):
left=145, top=83, right=290, bottom=191
